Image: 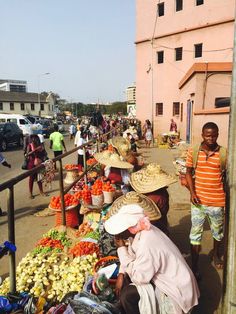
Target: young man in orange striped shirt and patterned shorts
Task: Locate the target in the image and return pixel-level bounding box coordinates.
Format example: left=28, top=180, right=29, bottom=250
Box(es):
left=186, top=122, right=225, bottom=279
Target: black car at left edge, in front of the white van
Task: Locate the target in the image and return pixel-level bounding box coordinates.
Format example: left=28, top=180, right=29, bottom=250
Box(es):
left=0, top=122, right=24, bottom=151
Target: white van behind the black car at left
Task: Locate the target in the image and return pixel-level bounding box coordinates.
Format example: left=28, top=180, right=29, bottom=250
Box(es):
left=0, top=113, right=33, bottom=136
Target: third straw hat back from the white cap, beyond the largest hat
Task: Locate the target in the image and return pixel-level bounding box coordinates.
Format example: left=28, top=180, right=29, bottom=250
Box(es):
left=94, top=151, right=133, bottom=169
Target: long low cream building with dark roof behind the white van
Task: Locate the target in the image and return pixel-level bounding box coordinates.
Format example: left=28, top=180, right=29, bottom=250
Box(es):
left=0, top=91, right=55, bottom=118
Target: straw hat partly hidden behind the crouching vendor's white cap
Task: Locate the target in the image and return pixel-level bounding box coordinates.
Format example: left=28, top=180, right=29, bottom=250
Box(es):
left=106, top=191, right=161, bottom=221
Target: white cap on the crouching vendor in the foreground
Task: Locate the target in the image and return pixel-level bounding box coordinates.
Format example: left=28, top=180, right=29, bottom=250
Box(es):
left=104, top=204, right=144, bottom=235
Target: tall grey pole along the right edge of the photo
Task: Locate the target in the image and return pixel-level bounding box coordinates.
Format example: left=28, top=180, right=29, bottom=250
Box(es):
left=221, top=8, right=236, bottom=314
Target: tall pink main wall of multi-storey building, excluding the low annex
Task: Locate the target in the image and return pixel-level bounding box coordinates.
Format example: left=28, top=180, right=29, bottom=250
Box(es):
left=136, top=0, right=235, bottom=140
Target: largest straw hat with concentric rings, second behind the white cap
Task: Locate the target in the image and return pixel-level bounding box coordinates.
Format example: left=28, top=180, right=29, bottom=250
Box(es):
left=130, top=163, right=177, bottom=194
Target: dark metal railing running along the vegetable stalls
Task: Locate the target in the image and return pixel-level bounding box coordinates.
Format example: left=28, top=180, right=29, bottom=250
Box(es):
left=0, top=126, right=119, bottom=293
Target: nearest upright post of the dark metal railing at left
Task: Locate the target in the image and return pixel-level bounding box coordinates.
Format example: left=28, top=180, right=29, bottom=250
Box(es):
left=7, top=186, right=16, bottom=293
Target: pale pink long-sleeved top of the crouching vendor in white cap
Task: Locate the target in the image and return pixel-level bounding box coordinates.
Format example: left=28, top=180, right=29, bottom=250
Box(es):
left=118, top=226, right=199, bottom=313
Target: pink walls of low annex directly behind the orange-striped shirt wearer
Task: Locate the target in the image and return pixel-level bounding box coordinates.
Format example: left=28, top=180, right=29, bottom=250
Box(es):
left=179, top=73, right=232, bottom=146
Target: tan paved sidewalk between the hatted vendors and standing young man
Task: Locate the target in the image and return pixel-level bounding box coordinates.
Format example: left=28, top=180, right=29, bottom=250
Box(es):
left=141, top=147, right=222, bottom=314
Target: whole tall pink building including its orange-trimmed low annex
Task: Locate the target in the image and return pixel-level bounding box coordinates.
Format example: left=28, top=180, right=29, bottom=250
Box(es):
left=136, top=0, right=235, bottom=145
